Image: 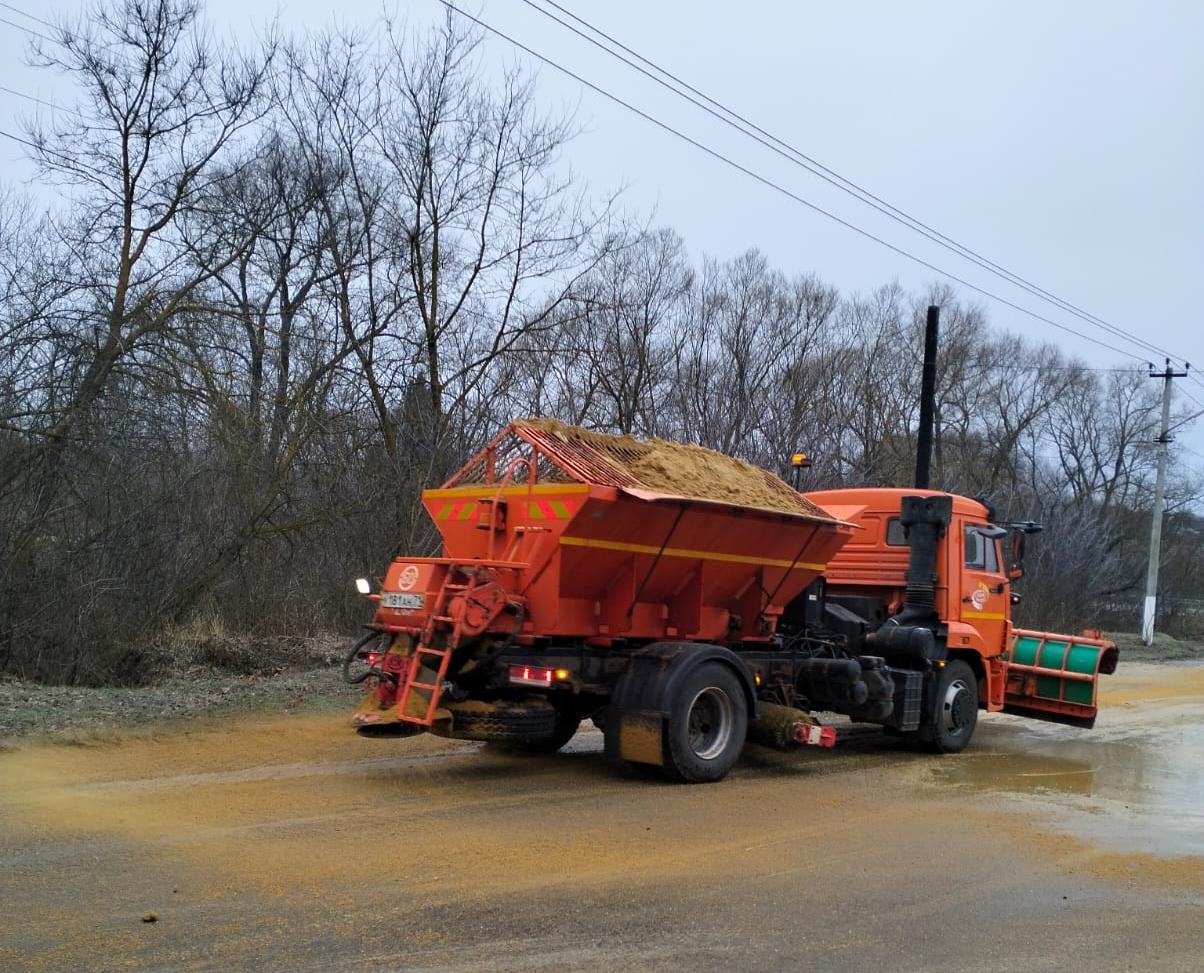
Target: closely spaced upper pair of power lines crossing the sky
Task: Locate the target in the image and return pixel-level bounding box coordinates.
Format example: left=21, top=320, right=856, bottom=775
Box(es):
left=523, top=0, right=1178, bottom=366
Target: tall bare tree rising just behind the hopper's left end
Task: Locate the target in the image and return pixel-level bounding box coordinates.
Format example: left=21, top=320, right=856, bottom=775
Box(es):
left=376, top=13, right=607, bottom=452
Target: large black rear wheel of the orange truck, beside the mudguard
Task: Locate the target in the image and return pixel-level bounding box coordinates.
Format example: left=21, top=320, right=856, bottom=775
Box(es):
left=662, top=662, right=748, bottom=784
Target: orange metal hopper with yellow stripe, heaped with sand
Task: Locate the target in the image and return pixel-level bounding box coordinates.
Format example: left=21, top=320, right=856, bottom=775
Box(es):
left=377, top=419, right=852, bottom=659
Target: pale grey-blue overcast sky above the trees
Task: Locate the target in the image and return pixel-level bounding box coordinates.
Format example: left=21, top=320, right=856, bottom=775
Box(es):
left=7, top=0, right=1204, bottom=464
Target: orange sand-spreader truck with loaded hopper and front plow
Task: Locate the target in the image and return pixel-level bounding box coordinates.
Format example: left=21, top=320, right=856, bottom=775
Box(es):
left=343, top=420, right=1117, bottom=782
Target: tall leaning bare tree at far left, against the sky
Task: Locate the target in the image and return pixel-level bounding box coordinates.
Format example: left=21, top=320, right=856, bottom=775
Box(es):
left=6, top=0, right=270, bottom=482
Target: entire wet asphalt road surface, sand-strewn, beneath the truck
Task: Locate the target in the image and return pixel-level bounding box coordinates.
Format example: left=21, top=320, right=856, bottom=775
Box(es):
left=0, top=665, right=1204, bottom=973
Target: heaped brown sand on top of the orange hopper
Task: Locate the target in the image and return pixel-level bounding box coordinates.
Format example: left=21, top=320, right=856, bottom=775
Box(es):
left=514, top=419, right=832, bottom=520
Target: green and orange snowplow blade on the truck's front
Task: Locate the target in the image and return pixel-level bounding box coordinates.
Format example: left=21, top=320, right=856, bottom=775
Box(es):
left=1003, top=629, right=1119, bottom=729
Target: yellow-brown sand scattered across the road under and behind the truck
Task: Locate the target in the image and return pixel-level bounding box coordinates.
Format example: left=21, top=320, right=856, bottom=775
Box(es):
left=0, top=666, right=1204, bottom=891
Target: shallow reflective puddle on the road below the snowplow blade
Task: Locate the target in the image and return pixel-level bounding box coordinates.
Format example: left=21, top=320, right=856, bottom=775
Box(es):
left=931, top=679, right=1204, bottom=856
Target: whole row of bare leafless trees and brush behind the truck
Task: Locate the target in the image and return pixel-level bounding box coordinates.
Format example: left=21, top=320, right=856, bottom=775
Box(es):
left=0, top=0, right=1204, bottom=682
